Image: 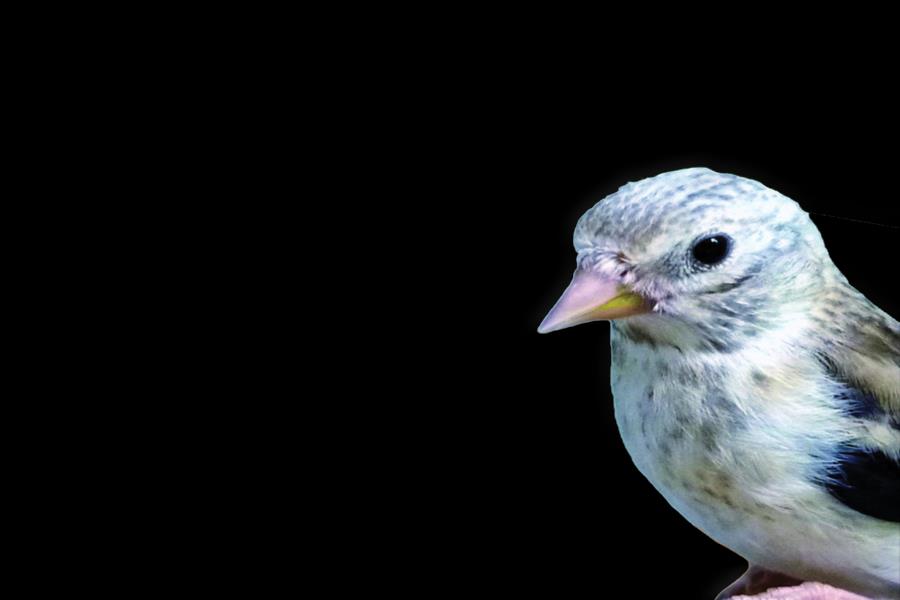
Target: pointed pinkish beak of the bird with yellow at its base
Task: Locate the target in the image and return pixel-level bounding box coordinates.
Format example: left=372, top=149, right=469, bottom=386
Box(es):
left=538, top=269, right=652, bottom=333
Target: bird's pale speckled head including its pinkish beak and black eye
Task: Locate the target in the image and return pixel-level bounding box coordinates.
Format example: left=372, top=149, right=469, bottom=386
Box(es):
left=538, top=168, right=841, bottom=350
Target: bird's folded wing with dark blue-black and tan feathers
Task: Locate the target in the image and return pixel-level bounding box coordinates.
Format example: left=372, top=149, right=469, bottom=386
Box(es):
left=821, top=300, right=900, bottom=522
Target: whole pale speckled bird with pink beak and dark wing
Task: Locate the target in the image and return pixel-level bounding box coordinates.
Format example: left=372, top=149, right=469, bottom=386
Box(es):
left=538, top=167, right=900, bottom=600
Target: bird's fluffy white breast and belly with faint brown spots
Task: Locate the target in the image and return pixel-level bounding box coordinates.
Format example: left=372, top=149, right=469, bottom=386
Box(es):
left=611, top=330, right=896, bottom=596
